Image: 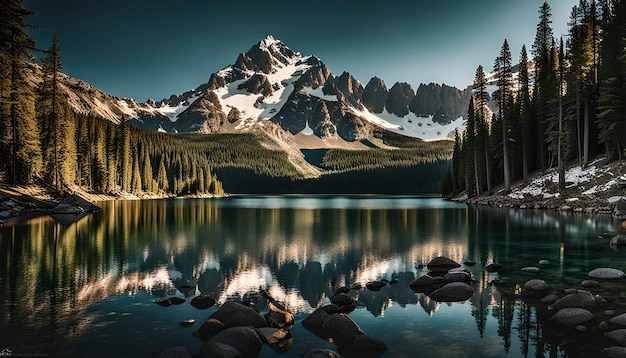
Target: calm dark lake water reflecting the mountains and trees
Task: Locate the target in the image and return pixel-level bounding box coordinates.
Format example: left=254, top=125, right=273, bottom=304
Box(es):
left=0, top=196, right=626, bottom=357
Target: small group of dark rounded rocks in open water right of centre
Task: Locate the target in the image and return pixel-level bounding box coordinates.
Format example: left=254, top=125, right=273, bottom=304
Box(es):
left=409, top=256, right=474, bottom=302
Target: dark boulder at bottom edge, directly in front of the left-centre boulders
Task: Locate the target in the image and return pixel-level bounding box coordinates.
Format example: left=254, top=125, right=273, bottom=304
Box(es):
left=200, top=327, right=263, bottom=358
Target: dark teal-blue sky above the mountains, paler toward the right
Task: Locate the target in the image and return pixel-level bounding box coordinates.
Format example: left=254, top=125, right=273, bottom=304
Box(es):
left=24, top=0, right=578, bottom=101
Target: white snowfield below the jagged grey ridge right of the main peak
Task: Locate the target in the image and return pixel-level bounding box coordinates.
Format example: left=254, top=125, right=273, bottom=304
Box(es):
left=353, top=108, right=465, bottom=140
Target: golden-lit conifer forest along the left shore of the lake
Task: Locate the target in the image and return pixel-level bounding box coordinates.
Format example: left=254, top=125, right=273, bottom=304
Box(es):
left=0, top=0, right=223, bottom=195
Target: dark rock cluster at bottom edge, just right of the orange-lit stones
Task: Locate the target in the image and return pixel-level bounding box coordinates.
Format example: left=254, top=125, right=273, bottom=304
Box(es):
left=302, top=287, right=387, bottom=358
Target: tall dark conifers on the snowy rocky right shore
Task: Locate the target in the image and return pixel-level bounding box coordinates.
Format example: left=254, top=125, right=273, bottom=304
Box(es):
left=444, top=0, right=626, bottom=197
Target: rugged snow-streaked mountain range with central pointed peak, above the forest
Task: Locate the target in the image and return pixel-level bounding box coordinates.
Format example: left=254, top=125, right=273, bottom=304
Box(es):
left=48, top=36, right=471, bottom=148
